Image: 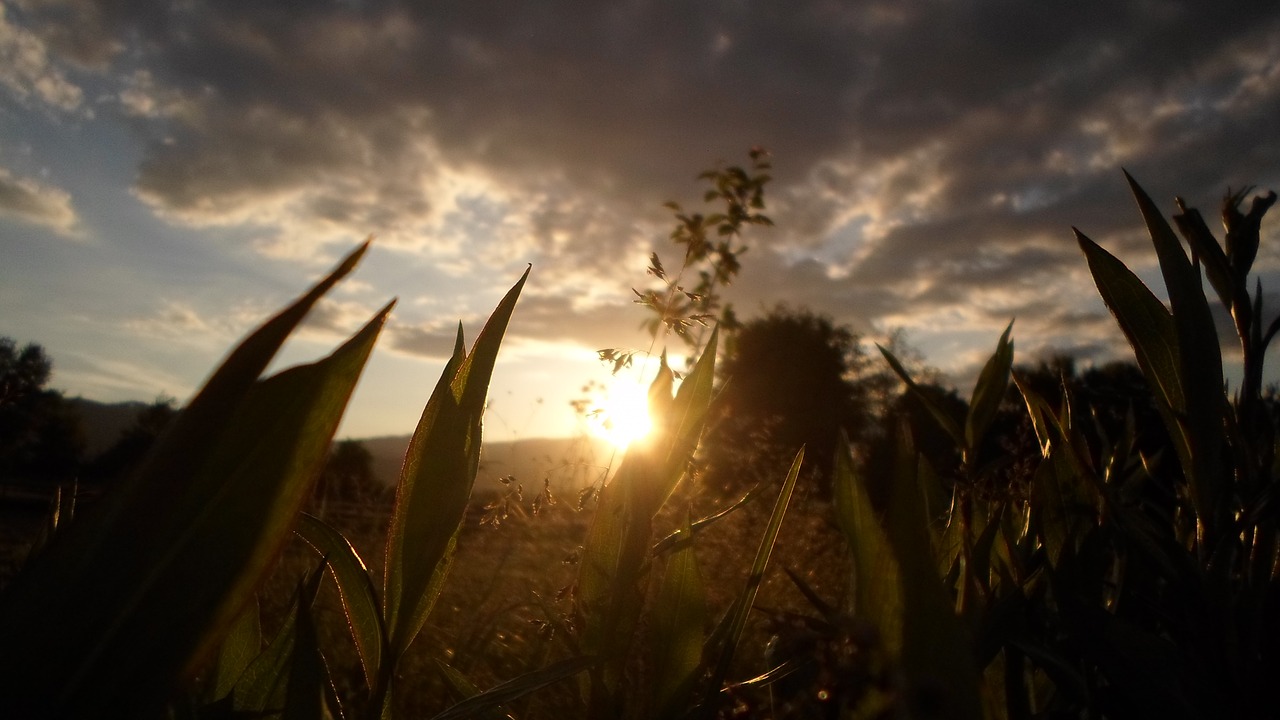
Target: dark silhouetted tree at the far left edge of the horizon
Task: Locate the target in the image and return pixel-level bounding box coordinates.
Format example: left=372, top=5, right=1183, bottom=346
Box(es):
left=0, top=337, right=84, bottom=483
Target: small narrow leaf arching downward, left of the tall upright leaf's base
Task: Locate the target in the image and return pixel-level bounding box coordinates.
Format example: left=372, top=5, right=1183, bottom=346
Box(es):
left=294, top=512, right=385, bottom=687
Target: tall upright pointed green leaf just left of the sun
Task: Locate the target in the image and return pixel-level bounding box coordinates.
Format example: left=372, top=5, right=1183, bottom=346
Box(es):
left=383, top=270, right=529, bottom=662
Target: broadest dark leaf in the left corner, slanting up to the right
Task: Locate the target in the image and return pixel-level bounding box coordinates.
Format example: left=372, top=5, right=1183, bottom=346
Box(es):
left=0, top=281, right=390, bottom=717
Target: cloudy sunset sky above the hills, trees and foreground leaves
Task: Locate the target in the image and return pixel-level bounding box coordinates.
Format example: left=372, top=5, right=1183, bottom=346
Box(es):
left=0, top=0, right=1280, bottom=439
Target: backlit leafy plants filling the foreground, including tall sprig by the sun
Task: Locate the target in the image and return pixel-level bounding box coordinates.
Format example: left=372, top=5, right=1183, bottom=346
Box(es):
left=0, top=162, right=1280, bottom=719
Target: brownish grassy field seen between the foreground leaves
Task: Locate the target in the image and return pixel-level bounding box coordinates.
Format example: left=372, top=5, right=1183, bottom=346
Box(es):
left=262, top=461, right=850, bottom=717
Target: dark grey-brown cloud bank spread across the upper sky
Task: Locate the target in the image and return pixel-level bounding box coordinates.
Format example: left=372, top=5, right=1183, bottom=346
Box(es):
left=15, top=0, right=1280, bottom=376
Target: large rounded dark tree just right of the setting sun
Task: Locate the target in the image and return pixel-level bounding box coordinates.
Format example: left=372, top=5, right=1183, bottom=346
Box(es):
left=704, top=306, right=868, bottom=497
